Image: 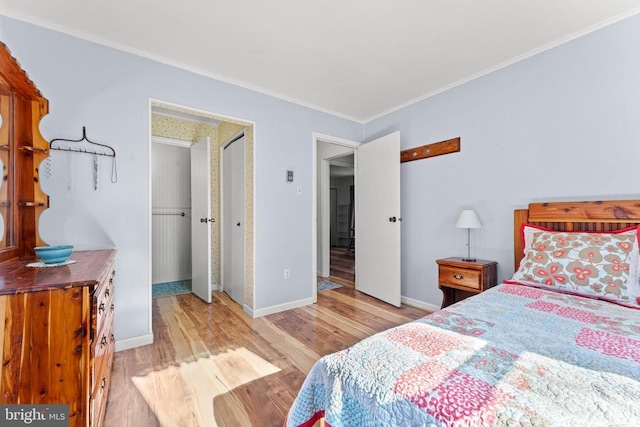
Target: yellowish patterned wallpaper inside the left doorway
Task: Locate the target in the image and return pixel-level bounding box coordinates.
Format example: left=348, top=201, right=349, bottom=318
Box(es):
left=151, top=102, right=254, bottom=309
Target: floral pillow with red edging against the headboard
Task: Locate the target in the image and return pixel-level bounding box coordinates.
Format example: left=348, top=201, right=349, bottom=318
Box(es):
left=512, top=226, right=640, bottom=307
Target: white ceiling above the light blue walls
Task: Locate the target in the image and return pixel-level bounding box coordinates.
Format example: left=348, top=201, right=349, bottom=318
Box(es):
left=0, top=0, right=640, bottom=122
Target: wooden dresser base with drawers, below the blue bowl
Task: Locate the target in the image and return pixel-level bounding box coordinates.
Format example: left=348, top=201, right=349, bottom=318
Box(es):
left=0, top=250, right=116, bottom=426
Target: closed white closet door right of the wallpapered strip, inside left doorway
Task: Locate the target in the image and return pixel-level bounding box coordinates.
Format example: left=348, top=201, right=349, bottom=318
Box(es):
left=222, top=136, right=245, bottom=305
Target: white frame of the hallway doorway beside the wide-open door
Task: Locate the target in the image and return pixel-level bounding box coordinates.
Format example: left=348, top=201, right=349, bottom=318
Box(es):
left=311, top=132, right=362, bottom=304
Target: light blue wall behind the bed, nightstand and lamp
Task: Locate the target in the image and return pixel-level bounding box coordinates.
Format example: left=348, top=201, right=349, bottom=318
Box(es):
left=364, top=16, right=640, bottom=305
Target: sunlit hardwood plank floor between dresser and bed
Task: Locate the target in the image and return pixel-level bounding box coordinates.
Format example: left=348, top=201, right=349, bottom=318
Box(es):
left=105, top=287, right=427, bottom=427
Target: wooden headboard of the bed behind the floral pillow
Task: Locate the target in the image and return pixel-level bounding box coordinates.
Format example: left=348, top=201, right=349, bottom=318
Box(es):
left=513, top=200, right=640, bottom=270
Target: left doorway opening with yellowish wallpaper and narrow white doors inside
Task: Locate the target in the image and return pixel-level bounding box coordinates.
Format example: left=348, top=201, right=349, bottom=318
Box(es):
left=149, top=100, right=254, bottom=314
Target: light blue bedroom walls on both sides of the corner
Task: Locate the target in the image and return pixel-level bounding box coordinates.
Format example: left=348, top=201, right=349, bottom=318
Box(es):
left=5, top=12, right=640, bottom=339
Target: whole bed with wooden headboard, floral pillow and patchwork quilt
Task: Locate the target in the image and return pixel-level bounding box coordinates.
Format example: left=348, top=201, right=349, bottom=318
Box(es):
left=286, top=200, right=640, bottom=427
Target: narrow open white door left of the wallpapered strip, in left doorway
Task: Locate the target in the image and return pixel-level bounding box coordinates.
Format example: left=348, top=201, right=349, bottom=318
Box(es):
left=191, top=137, right=214, bottom=303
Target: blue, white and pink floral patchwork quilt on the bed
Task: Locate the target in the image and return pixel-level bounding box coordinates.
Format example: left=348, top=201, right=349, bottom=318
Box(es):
left=286, top=283, right=640, bottom=427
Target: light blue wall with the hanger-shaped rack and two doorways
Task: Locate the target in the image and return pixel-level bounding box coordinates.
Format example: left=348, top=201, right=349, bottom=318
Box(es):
left=0, top=17, right=362, bottom=340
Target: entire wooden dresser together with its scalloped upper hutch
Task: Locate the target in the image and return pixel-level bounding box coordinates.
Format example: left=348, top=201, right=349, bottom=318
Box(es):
left=0, top=43, right=115, bottom=426
